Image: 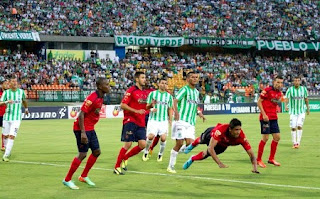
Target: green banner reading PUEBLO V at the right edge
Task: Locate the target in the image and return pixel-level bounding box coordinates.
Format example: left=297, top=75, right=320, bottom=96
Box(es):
left=257, top=40, right=320, bottom=51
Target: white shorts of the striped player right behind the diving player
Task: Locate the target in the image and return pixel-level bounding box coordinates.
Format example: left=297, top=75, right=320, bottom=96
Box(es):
left=171, top=120, right=196, bottom=140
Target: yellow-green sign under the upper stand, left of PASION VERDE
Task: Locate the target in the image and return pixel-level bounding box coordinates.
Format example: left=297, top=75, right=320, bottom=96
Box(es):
left=46, top=49, right=85, bottom=61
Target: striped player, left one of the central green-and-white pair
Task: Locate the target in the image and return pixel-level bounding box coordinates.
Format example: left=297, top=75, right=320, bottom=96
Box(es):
left=142, top=78, right=173, bottom=162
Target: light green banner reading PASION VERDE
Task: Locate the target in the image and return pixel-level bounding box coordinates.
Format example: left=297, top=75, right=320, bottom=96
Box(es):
left=114, top=35, right=184, bottom=47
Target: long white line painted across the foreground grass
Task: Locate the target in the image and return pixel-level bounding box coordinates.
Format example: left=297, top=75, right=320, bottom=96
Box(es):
left=10, top=160, right=320, bottom=190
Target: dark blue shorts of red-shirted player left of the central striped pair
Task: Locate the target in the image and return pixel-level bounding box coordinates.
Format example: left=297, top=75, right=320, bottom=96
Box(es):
left=121, top=122, right=146, bottom=142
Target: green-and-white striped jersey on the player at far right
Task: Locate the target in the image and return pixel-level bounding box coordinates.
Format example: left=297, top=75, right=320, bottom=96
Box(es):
left=286, top=86, right=308, bottom=115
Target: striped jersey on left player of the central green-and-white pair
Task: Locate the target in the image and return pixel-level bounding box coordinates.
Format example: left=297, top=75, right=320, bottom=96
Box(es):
left=147, top=90, right=173, bottom=122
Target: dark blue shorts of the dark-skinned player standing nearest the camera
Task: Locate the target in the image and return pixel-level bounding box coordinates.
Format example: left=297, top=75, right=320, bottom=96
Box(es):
left=73, top=130, right=100, bottom=152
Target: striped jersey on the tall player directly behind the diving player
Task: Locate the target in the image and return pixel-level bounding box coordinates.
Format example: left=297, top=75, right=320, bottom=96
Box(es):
left=176, top=85, right=200, bottom=126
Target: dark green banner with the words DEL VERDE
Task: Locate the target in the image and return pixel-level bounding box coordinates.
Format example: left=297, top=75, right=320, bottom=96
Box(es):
left=185, top=37, right=255, bottom=48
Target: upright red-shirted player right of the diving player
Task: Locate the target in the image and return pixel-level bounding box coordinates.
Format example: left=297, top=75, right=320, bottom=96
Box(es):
left=257, top=76, right=283, bottom=168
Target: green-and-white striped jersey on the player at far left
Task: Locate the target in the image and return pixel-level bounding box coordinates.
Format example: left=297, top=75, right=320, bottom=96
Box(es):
left=0, top=88, right=26, bottom=121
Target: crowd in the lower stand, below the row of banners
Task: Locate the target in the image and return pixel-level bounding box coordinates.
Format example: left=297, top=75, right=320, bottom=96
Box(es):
left=0, top=51, right=320, bottom=101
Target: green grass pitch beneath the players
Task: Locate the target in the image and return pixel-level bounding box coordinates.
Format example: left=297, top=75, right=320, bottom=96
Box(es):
left=0, top=113, right=320, bottom=199
